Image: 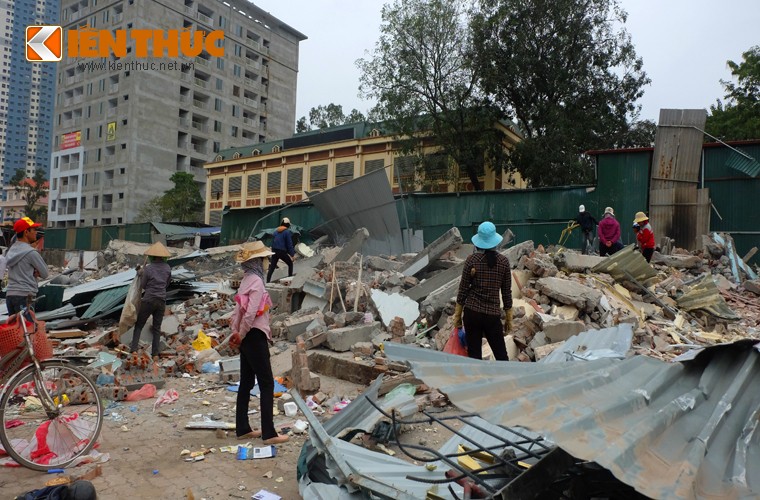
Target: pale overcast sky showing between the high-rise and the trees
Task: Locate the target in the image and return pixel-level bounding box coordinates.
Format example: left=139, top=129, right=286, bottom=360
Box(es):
left=254, top=0, right=760, bottom=121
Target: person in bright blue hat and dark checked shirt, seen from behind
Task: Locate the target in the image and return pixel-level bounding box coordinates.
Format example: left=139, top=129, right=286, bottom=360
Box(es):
left=454, top=221, right=512, bottom=361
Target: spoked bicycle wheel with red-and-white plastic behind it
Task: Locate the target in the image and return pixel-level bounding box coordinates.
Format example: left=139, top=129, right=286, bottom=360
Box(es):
left=0, top=360, right=103, bottom=471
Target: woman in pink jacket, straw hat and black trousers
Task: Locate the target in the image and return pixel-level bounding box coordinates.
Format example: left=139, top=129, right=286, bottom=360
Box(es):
left=230, top=241, right=288, bottom=444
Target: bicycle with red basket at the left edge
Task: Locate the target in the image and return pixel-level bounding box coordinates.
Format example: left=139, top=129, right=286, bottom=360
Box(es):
left=0, top=300, right=103, bottom=471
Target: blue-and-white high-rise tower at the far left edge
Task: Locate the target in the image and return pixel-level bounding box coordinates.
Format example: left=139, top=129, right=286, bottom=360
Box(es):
left=0, top=0, right=60, bottom=213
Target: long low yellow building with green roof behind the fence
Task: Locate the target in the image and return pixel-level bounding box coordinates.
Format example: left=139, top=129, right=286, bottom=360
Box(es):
left=204, top=122, right=526, bottom=225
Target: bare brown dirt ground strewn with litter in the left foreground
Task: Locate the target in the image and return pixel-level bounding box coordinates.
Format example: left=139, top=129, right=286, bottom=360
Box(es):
left=0, top=351, right=378, bottom=500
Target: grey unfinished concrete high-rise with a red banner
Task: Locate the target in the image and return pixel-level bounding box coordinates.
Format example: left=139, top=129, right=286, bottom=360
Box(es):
left=48, top=0, right=306, bottom=227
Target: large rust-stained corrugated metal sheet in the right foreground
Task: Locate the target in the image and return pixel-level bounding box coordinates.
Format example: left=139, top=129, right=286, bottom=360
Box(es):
left=385, top=341, right=760, bottom=499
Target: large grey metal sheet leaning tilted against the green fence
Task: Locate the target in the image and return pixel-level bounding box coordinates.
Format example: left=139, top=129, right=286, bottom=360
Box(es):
left=308, top=170, right=404, bottom=255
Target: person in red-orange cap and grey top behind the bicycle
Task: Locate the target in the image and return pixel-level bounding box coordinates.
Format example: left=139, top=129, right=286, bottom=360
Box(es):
left=5, top=217, right=48, bottom=315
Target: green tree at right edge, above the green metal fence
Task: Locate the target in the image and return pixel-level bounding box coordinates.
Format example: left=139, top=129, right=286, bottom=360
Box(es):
left=705, top=46, right=760, bottom=141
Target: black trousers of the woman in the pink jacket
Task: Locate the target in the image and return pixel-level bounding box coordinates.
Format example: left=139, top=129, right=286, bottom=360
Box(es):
left=235, top=328, right=277, bottom=439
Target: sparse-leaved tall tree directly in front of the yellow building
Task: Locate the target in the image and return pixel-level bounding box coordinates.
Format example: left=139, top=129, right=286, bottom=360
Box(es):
left=357, top=0, right=504, bottom=189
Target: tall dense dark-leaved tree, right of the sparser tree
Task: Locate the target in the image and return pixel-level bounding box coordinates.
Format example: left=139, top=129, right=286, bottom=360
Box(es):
left=471, top=0, right=650, bottom=186
